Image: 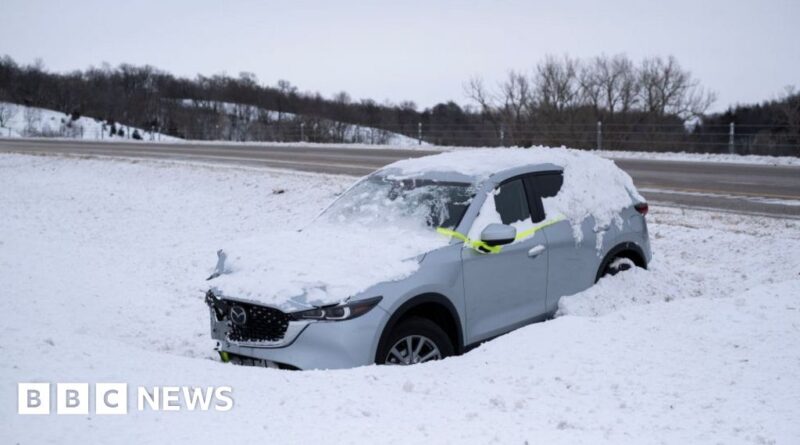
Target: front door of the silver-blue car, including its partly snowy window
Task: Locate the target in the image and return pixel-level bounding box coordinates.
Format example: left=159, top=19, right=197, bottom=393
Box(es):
left=462, top=177, right=548, bottom=343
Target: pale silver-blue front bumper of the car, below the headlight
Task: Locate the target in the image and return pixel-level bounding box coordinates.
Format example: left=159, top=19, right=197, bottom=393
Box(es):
left=209, top=294, right=388, bottom=369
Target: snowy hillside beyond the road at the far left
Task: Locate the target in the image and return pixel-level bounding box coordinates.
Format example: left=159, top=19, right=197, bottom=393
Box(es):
left=0, top=102, right=180, bottom=142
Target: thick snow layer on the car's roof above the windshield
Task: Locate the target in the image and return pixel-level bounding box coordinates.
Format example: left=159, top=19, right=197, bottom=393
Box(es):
left=378, top=147, right=563, bottom=182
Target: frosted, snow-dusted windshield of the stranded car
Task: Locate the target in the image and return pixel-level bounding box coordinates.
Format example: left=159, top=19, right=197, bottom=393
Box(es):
left=321, top=175, right=474, bottom=229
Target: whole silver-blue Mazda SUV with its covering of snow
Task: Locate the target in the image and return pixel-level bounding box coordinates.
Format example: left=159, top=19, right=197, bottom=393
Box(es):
left=206, top=148, right=651, bottom=369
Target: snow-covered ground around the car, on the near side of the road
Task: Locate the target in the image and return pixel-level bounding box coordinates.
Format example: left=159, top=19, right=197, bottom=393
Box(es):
left=0, top=155, right=800, bottom=444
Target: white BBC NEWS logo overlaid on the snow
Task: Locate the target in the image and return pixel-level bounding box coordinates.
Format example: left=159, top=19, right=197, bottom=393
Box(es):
left=17, top=383, right=233, bottom=415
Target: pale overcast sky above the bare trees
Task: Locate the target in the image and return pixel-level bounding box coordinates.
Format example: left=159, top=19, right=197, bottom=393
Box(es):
left=0, top=0, right=800, bottom=110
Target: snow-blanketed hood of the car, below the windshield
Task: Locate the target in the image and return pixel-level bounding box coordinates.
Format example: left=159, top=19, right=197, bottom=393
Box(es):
left=204, top=225, right=448, bottom=312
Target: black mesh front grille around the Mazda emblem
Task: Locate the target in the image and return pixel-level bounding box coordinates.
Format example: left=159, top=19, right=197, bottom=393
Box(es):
left=228, top=302, right=289, bottom=342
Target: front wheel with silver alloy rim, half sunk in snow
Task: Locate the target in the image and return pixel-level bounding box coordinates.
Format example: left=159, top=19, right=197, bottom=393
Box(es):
left=376, top=317, right=455, bottom=366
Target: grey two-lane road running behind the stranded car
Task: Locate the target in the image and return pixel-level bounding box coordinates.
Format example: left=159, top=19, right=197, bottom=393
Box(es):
left=0, top=139, right=800, bottom=218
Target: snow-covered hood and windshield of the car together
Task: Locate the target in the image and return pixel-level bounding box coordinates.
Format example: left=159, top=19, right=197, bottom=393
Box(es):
left=209, top=176, right=472, bottom=311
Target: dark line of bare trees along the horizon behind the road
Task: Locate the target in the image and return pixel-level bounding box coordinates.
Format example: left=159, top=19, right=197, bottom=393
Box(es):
left=0, top=55, right=800, bottom=155
